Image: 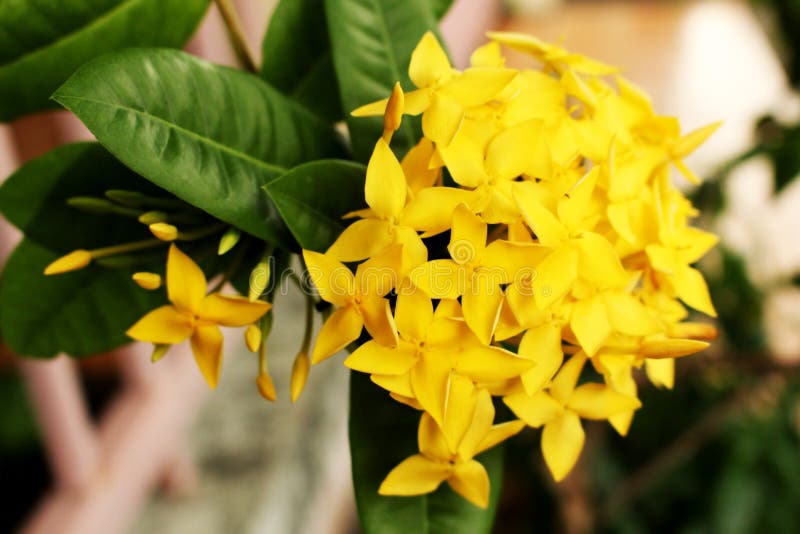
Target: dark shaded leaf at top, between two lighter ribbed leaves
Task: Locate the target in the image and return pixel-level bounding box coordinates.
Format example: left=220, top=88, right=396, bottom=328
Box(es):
left=261, top=0, right=343, bottom=122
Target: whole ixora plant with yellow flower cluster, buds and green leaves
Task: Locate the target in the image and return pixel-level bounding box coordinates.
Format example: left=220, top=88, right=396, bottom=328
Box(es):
left=0, top=0, right=717, bottom=532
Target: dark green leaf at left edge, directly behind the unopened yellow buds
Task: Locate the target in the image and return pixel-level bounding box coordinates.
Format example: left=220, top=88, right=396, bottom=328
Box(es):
left=0, top=143, right=163, bottom=253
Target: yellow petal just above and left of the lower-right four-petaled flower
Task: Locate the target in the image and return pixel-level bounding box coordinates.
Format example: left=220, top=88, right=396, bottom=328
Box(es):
left=519, top=323, right=564, bottom=395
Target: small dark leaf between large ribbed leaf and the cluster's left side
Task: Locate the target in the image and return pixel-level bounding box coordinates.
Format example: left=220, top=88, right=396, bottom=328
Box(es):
left=265, top=160, right=367, bottom=252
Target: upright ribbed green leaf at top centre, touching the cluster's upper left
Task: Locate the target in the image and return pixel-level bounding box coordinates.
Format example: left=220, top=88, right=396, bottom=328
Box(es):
left=325, top=0, right=441, bottom=162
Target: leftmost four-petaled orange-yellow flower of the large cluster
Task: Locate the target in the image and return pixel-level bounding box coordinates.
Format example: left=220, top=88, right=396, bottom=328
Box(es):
left=303, top=245, right=402, bottom=364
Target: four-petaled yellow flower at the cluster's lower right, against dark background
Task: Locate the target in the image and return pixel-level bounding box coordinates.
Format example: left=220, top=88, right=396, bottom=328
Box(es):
left=510, top=353, right=641, bottom=481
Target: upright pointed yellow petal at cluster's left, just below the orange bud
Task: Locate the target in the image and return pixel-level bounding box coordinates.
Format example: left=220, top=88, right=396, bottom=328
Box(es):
left=364, top=139, right=406, bottom=219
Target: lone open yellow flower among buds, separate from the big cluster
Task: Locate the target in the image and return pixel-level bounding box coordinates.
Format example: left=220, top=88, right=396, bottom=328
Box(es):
left=127, top=245, right=270, bottom=389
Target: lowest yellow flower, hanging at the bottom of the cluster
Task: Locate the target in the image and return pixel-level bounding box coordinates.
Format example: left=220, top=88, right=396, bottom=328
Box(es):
left=378, top=386, right=525, bottom=508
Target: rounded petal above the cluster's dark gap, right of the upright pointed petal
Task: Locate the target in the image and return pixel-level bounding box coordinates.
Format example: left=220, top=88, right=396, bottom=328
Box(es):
left=400, top=187, right=473, bottom=237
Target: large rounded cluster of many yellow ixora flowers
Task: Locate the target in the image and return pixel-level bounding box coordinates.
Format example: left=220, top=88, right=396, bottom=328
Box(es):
left=304, top=33, right=718, bottom=507
